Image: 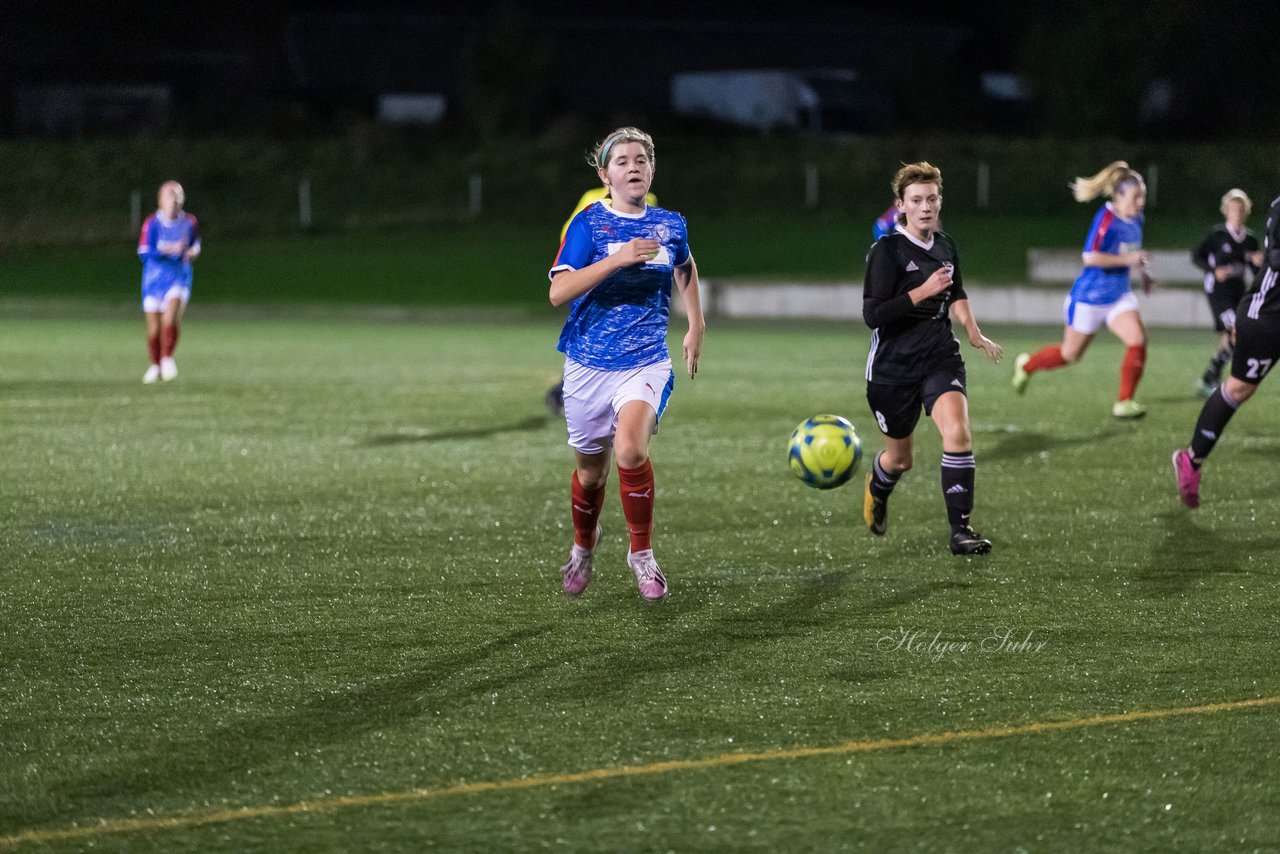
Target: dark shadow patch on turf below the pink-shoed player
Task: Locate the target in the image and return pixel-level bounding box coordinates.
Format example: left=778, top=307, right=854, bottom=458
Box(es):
left=1134, top=508, right=1280, bottom=595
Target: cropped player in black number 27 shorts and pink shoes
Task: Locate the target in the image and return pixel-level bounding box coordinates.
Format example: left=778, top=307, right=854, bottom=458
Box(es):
left=1174, top=198, right=1280, bottom=507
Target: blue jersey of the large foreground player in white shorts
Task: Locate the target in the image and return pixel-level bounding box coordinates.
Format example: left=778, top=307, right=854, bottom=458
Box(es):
left=550, top=202, right=690, bottom=371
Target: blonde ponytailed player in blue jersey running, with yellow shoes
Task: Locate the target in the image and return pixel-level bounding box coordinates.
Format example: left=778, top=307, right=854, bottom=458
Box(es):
left=1014, top=160, right=1155, bottom=419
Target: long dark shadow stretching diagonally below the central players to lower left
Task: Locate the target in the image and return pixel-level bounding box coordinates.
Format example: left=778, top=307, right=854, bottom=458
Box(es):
left=30, top=572, right=966, bottom=826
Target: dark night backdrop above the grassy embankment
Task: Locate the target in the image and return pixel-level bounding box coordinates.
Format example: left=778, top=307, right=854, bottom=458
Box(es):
left=0, top=0, right=1280, bottom=140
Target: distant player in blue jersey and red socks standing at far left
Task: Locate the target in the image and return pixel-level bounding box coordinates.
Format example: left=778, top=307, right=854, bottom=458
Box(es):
left=138, top=181, right=200, bottom=383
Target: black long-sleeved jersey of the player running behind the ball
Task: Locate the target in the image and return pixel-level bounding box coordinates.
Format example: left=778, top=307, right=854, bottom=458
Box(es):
left=863, top=229, right=969, bottom=385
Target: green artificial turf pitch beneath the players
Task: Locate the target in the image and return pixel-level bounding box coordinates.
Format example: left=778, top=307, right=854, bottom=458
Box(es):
left=0, top=316, right=1280, bottom=851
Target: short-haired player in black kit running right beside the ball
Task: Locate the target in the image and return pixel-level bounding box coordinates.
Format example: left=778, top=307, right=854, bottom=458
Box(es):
left=863, top=161, right=1004, bottom=554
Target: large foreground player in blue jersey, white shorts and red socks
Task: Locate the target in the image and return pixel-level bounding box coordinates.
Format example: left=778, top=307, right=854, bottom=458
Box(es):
left=549, top=127, right=705, bottom=599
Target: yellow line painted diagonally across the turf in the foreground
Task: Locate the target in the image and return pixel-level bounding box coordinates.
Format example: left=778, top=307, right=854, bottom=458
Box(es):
left=0, top=697, right=1280, bottom=848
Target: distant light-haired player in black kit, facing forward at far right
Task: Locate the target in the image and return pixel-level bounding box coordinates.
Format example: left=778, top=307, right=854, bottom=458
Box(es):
left=1192, top=189, right=1262, bottom=397
